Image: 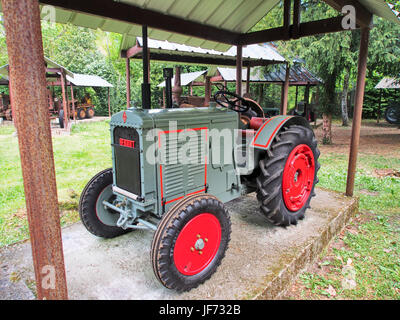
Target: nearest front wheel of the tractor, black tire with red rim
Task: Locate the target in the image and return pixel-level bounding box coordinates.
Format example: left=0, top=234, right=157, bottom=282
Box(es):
left=151, top=194, right=231, bottom=291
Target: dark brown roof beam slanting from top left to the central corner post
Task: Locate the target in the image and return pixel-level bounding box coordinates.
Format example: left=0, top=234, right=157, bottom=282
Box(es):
left=40, top=0, right=240, bottom=45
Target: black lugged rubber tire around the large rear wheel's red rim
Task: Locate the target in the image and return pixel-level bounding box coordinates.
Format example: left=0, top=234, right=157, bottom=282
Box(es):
left=256, top=125, right=320, bottom=227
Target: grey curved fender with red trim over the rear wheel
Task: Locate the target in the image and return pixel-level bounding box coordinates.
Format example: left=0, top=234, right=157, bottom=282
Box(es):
left=250, top=115, right=312, bottom=150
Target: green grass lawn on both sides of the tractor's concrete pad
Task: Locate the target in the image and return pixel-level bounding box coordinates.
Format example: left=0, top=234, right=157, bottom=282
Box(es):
left=0, top=121, right=400, bottom=299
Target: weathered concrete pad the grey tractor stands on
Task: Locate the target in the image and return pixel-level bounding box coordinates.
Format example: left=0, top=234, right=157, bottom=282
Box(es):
left=0, top=189, right=358, bottom=300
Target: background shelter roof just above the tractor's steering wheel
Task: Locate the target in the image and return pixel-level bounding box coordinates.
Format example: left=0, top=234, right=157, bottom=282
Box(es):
left=217, top=64, right=322, bottom=85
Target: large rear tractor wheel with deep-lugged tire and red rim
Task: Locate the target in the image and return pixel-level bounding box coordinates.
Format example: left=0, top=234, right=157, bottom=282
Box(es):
left=257, top=125, right=320, bottom=226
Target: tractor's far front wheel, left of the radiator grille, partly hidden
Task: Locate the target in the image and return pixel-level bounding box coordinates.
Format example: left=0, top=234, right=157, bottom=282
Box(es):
left=79, top=169, right=130, bottom=238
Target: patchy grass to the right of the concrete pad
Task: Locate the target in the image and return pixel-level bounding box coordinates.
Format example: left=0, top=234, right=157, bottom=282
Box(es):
left=286, top=155, right=400, bottom=299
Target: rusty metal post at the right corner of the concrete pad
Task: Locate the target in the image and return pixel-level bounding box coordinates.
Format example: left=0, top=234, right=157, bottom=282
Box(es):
left=346, top=28, right=369, bottom=197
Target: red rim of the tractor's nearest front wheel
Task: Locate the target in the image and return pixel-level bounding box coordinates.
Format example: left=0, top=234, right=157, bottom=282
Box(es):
left=174, top=213, right=221, bottom=276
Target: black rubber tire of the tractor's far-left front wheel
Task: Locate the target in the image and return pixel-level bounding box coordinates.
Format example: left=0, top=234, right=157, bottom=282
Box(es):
left=79, top=169, right=131, bottom=238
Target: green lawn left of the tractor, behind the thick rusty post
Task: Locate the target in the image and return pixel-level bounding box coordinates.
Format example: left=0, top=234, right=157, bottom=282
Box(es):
left=0, top=121, right=111, bottom=246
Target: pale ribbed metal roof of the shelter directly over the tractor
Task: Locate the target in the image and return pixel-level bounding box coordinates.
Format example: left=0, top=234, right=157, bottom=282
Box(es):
left=0, top=0, right=400, bottom=51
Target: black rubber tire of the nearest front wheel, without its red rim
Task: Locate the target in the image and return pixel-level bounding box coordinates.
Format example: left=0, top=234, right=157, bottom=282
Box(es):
left=150, top=194, right=231, bottom=292
